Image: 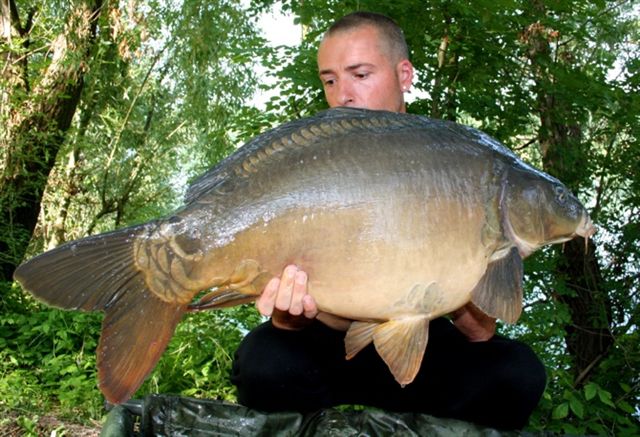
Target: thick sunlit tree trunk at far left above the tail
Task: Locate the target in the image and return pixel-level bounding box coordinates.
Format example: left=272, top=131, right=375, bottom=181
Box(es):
left=0, top=0, right=103, bottom=280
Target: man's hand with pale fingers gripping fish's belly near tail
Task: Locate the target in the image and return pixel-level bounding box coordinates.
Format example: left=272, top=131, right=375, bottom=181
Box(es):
left=256, top=265, right=351, bottom=331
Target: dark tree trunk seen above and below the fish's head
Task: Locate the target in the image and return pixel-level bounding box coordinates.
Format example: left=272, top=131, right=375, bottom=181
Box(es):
left=522, top=17, right=613, bottom=385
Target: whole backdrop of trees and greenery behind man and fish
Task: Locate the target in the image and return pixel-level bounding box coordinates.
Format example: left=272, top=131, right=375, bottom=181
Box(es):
left=0, top=0, right=640, bottom=435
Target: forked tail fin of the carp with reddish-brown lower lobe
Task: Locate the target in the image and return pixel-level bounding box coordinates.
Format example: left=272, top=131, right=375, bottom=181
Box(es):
left=14, top=225, right=186, bottom=403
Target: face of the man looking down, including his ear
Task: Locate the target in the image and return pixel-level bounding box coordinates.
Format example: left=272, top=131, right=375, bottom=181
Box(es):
left=318, top=26, right=413, bottom=112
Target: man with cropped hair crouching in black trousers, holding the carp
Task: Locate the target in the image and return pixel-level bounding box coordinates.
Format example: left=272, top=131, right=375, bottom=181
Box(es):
left=232, top=12, right=546, bottom=429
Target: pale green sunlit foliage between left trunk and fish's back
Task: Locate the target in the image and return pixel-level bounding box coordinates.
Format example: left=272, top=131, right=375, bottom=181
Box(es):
left=23, top=1, right=262, bottom=247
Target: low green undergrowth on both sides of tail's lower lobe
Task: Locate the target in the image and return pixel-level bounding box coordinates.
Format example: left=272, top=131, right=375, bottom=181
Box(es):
left=0, top=276, right=260, bottom=421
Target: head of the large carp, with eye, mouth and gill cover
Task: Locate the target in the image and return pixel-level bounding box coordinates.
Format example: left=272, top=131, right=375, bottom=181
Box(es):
left=501, top=167, right=596, bottom=256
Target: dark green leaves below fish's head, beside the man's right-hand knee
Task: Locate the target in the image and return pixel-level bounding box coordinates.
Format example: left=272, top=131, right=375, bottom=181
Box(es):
left=501, top=245, right=640, bottom=436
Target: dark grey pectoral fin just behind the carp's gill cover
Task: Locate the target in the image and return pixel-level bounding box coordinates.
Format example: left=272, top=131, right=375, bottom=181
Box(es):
left=471, top=247, right=523, bottom=323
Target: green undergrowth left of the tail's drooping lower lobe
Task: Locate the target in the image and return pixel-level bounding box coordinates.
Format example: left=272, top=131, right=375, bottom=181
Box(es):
left=0, top=284, right=102, bottom=419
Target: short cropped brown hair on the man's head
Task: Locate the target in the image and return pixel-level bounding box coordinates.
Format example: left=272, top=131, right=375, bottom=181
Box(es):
left=324, top=11, right=409, bottom=60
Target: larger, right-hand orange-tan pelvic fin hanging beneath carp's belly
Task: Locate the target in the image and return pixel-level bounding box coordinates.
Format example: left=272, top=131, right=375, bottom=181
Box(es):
left=373, top=316, right=429, bottom=387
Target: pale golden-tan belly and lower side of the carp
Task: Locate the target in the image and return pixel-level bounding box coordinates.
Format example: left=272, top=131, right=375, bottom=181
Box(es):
left=207, top=186, right=487, bottom=320
